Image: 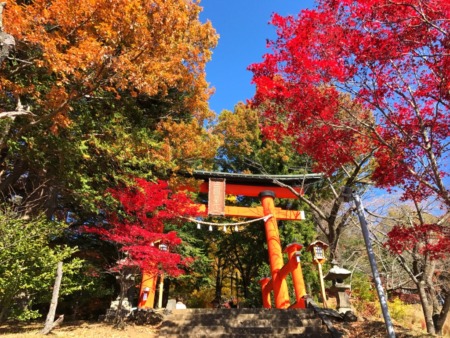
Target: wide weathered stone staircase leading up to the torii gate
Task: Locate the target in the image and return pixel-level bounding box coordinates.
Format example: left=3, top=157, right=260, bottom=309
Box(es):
left=159, top=309, right=334, bottom=338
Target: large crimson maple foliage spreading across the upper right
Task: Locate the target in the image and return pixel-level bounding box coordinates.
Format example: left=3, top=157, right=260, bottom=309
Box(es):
left=250, top=0, right=450, bottom=207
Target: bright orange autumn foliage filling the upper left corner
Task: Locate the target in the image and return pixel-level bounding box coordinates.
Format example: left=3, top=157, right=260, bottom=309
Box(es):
left=0, top=0, right=217, bottom=128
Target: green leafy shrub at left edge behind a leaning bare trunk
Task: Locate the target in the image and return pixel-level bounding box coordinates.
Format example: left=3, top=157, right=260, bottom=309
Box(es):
left=0, top=210, right=82, bottom=322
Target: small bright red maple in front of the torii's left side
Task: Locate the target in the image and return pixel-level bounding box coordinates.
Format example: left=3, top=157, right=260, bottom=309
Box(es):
left=85, top=178, right=198, bottom=276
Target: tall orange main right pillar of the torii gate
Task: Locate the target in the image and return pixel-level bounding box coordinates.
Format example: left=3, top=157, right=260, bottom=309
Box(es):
left=259, top=190, right=290, bottom=309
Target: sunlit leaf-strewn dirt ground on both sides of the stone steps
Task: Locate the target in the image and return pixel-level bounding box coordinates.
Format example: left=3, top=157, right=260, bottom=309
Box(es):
left=0, top=320, right=438, bottom=338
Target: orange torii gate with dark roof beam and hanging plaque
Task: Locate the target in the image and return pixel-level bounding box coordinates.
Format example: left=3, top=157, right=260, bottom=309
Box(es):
left=139, top=171, right=322, bottom=309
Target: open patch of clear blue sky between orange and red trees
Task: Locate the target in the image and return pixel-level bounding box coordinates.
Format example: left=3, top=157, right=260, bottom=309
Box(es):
left=200, top=0, right=315, bottom=114
